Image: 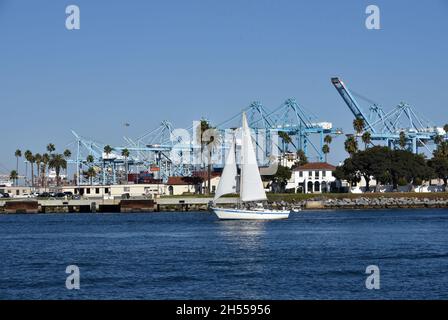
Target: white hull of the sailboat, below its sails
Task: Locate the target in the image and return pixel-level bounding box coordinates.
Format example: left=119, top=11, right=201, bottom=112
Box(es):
left=211, top=208, right=289, bottom=220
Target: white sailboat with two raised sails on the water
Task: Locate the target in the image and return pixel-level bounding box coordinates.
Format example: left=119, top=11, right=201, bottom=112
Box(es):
left=211, top=112, right=289, bottom=220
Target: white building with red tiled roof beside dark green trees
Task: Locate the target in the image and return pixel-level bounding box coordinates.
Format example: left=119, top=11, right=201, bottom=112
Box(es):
left=286, top=162, right=336, bottom=193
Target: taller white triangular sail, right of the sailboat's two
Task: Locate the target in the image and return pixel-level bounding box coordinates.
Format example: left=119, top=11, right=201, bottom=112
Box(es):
left=240, top=112, right=267, bottom=202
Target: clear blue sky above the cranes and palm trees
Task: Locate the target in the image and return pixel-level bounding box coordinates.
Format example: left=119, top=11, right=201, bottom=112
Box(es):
left=0, top=0, right=448, bottom=172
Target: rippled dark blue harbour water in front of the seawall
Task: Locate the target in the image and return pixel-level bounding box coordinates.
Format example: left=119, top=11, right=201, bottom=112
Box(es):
left=0, top=210, right=448, bottom=299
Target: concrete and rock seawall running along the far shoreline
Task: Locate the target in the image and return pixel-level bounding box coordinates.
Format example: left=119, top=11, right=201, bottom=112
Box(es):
left=0, top=195, right=448, bottom=214
